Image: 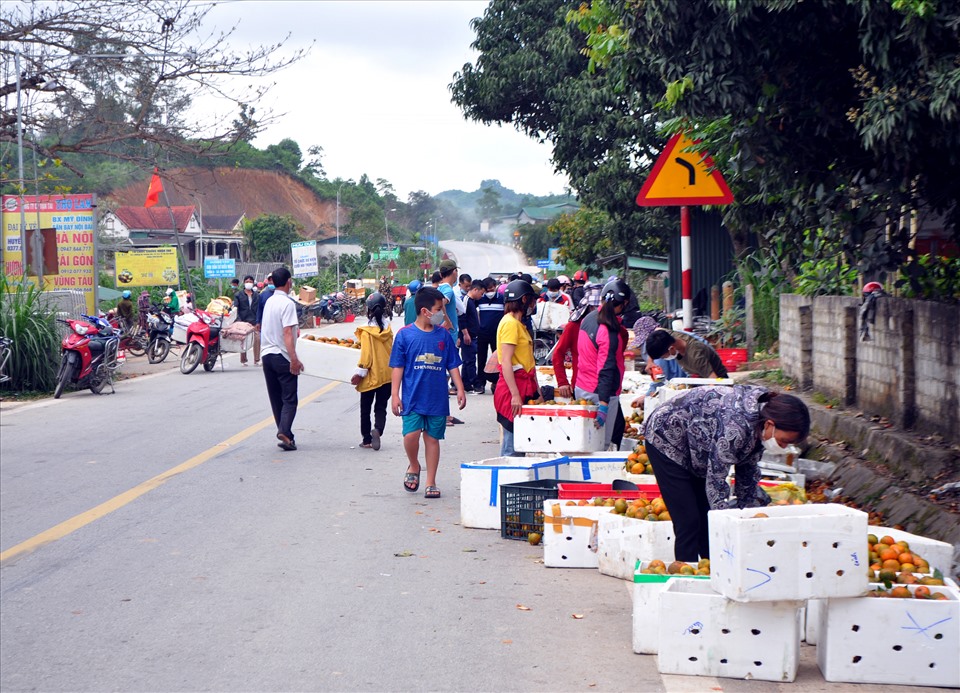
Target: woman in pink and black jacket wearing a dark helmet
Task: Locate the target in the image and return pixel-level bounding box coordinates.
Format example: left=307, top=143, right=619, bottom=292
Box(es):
left=574, top=280, right=633, bottom=449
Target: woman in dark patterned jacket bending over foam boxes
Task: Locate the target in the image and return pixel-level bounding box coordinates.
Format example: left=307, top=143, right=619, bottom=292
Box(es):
left=644, top=385, right=810, bottom=563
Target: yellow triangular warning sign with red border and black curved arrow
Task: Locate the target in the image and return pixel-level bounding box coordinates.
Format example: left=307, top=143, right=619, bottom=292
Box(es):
left=637, top=133, right=733, bottom=207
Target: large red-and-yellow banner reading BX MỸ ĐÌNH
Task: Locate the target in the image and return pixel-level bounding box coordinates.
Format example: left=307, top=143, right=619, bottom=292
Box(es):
left=0, top=194, right=96, bottom=313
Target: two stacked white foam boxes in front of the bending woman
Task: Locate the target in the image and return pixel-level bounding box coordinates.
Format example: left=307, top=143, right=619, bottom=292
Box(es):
left=658, top=505, right=868, bottom=681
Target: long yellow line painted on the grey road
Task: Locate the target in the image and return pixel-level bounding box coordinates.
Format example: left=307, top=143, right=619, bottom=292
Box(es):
left=0, top=382, right=340, bottom=565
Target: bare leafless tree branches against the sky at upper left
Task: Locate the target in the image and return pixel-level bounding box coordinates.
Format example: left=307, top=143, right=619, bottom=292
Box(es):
left=0, top=0, right=304, bottom=181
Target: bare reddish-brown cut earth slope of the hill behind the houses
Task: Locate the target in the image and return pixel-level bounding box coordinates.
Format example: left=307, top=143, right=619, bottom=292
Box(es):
left=102, top=168, right=338, bottom=240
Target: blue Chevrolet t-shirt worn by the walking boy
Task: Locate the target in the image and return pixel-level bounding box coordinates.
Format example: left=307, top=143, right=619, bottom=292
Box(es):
left=390, top=322, right=462, bottom=416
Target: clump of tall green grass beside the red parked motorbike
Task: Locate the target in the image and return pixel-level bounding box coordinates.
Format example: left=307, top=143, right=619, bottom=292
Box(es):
left=0, top=276, right=61, bottom=392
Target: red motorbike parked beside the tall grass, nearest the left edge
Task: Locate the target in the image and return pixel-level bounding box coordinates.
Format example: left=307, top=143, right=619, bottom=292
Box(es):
left=53, top=315, right=123, bottom=399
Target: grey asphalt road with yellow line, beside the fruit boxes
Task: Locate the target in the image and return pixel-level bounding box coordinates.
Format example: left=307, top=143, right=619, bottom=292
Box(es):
left=0, top=243, right=944, bottom=693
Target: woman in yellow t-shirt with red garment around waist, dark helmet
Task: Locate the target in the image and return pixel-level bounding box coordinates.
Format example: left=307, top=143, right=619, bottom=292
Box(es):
left=493, top=279, right=540, bottom=457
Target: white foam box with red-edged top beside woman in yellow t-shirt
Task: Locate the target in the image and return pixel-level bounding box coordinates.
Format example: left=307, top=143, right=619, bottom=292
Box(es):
left=513, top=405, right=603, bottom=452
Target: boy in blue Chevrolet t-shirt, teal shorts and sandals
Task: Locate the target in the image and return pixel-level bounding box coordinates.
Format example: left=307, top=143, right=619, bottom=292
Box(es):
left=390, top=286, right=467, bottom=498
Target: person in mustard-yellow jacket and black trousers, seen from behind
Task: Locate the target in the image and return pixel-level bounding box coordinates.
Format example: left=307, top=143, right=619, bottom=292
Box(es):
left=350, top=292, right=393, bottom=450
